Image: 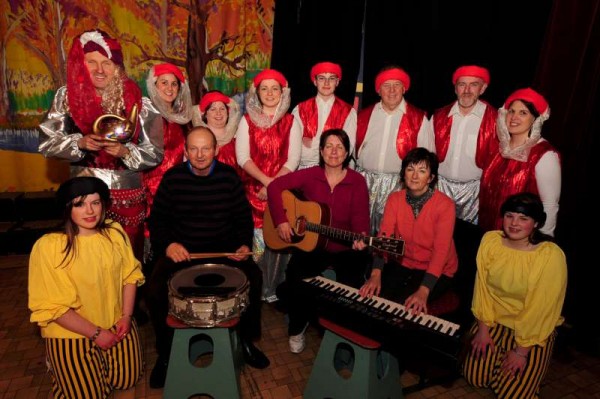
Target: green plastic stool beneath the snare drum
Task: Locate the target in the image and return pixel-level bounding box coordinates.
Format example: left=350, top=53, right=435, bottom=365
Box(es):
left=163, top=315, right=241, bottom=399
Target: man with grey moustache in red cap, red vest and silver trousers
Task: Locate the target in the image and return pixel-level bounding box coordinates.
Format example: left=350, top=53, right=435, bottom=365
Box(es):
left=430, top=65, right=498, bottom=225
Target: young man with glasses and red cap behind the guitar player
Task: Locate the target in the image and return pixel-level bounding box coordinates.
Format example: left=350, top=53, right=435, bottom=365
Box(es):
left=292, top=62, right=356, bottom=169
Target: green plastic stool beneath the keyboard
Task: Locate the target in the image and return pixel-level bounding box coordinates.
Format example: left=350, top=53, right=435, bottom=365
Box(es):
left=304, top=318, right=404, bottom=399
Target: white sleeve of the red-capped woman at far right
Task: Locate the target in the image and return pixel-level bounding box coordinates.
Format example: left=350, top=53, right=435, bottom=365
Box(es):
left=535, top=151, right=561, bottom=236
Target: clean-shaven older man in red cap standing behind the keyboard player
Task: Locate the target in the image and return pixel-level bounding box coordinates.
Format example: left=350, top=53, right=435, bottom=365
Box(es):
left=356, top=66, right=433, bottom=234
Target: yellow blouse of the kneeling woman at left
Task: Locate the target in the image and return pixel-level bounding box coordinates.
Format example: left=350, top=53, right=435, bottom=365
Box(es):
left=29, top=222, right=144, bottom=338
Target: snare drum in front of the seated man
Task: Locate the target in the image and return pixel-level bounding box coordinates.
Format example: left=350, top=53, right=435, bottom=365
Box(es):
left=169, top=263, right=250, bottom=327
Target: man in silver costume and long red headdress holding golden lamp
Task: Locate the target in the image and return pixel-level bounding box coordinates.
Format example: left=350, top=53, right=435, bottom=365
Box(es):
left=39, top=30, right=163, bottom=260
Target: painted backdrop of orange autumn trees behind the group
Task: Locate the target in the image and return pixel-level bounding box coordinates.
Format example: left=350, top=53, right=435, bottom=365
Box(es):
left=0, top=0, right=275, bottom=192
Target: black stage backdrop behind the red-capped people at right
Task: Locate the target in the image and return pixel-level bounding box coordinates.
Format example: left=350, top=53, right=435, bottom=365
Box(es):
left=271, top=0, right=600, bottom=355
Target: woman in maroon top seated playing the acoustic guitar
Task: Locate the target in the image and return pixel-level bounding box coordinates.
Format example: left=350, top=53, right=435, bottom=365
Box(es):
left=265, top=129, right=369, bottom=353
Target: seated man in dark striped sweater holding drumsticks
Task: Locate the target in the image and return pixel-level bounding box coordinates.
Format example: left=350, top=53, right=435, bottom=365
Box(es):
left=148, top=127, right=269, bottom=388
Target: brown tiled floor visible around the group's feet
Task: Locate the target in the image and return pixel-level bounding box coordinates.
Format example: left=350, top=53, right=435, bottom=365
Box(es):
left=0, top=255, right=600, bottom=399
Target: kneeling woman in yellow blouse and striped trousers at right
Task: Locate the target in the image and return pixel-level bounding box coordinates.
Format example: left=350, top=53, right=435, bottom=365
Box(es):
left=463, top=193, right=567, bottom=399
